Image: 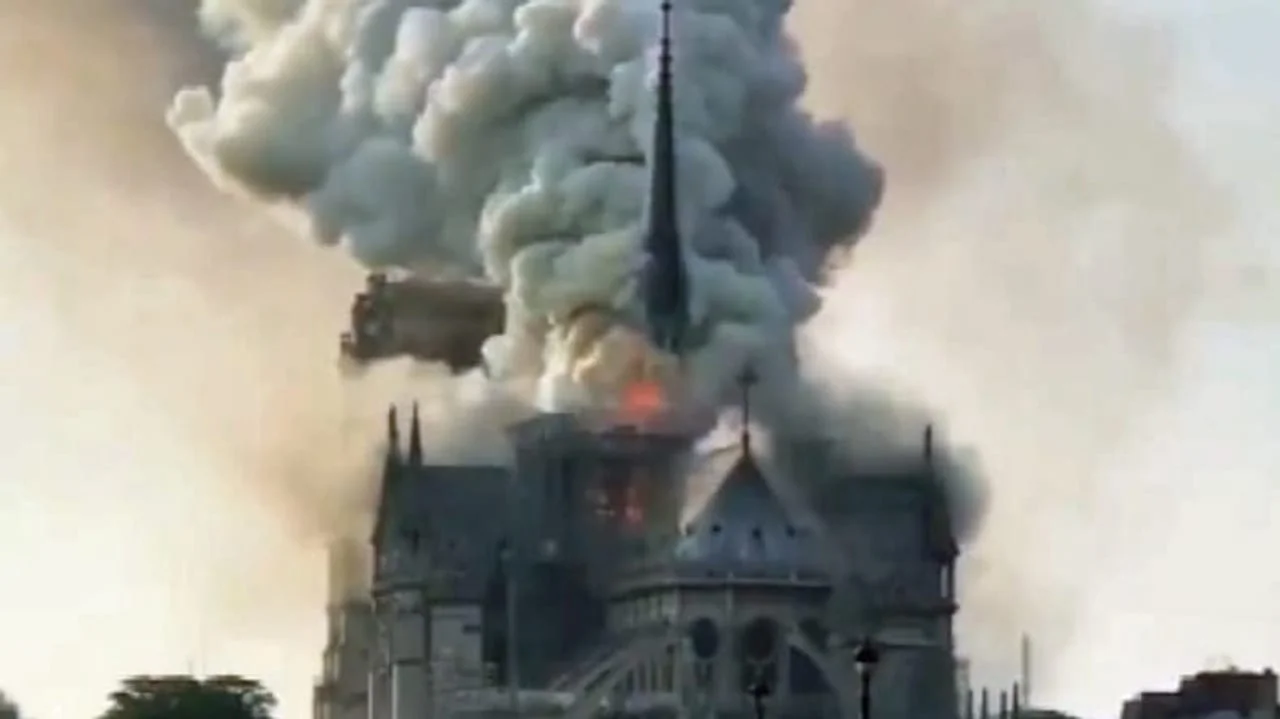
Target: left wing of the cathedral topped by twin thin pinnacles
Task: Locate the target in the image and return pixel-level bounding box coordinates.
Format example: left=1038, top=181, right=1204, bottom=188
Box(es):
left=369, top=407, right=507, bottom=719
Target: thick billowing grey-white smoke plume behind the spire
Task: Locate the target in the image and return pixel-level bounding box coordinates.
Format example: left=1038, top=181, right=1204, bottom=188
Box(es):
left=169, top=0, right=881, bottom=407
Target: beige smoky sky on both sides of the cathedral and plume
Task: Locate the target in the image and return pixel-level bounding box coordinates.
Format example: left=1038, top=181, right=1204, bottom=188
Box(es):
left=0, top=0, right=1280, bottom=719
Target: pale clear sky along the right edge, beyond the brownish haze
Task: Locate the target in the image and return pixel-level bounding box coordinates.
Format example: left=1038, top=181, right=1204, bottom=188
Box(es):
left=1039, top=0, right=1280, bottom=701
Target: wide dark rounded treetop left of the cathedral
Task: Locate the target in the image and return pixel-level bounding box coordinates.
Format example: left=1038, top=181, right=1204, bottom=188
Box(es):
left=100, top=676, right=275, bottom=719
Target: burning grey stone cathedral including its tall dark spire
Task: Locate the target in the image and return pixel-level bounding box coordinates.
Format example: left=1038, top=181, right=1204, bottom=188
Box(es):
left=315, top=6, right=960, bottom=719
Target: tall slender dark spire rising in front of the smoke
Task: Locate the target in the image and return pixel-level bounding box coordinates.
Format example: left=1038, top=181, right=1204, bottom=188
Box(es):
left=644, top=0, right=689, bottom=356
